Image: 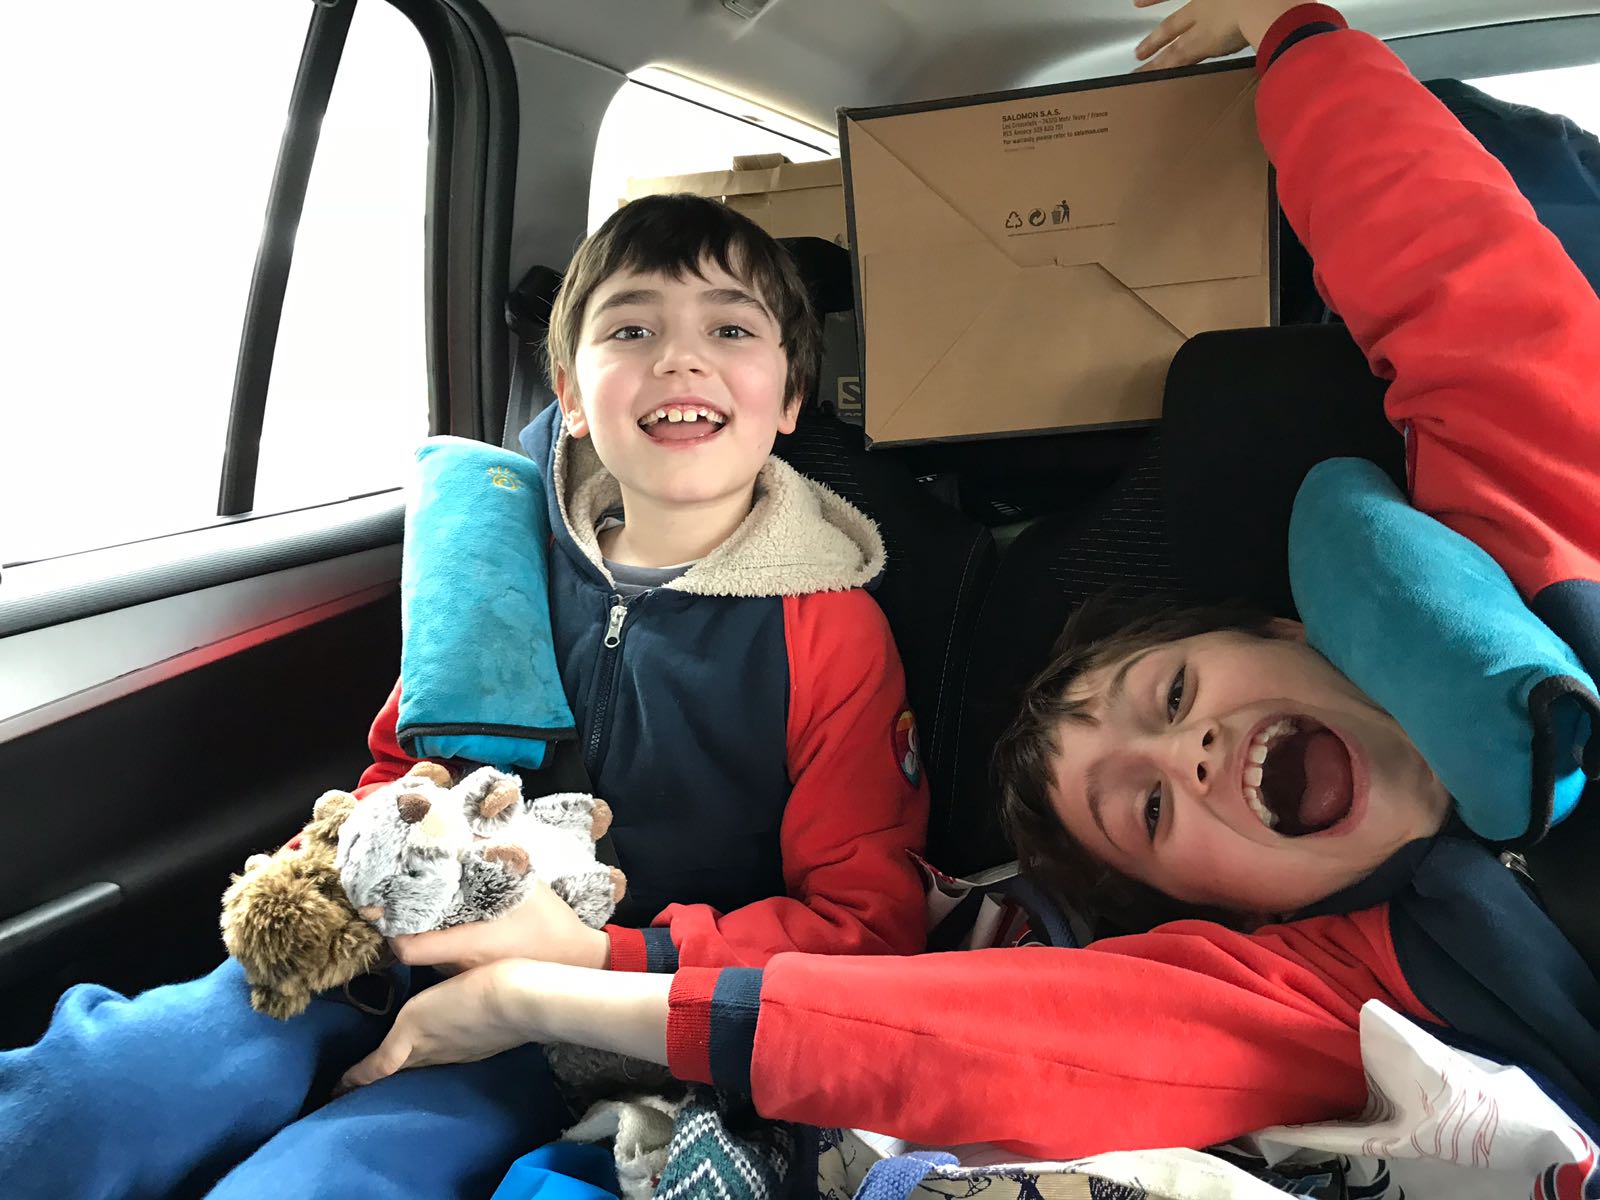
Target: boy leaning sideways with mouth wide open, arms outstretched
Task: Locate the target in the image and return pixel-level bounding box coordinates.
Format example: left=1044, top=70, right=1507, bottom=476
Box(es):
left=340, top=0, right=1600, bottom=1158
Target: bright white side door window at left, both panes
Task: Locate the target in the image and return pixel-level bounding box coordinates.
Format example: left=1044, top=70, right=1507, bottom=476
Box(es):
left=0, top=0, right=430, bottom=563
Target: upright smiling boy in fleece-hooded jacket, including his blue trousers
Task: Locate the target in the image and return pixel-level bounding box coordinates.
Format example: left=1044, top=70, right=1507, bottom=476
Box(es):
left=0, top=195, right=928, bottom=1200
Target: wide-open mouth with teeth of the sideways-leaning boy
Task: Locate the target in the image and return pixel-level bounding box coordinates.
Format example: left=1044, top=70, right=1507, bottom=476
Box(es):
left=1240, top=717, right=1355, bottom=837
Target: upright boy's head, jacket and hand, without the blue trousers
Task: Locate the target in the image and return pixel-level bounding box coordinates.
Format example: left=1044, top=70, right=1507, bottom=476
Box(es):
left=362, top=195, right=926, bottom=971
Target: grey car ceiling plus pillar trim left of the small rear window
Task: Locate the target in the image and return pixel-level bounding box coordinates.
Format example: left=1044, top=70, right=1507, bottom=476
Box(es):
left=483, top=0, right=1600, bottom=282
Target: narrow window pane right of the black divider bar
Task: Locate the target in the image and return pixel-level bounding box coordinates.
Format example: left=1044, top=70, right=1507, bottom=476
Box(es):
left=256, top=3, right=432, bottom=512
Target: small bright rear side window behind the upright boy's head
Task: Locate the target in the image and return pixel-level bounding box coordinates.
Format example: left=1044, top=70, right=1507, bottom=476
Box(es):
left=589, top=67, right=838, bottom=240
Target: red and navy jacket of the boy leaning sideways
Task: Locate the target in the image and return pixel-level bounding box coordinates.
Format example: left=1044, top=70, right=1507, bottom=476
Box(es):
left=652, top=5, right=1600, bottom=1158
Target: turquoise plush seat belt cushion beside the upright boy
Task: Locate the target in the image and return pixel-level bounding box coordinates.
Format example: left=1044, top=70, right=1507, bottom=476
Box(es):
left=397, top=437, right=576, bottom=770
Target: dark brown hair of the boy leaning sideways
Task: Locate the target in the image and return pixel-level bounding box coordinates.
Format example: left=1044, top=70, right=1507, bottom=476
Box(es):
left=994, top=592, right=1272, bottom=933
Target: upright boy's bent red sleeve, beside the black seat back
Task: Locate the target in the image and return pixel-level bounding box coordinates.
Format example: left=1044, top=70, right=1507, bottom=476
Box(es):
left=636, top=590, right=928, bottom=966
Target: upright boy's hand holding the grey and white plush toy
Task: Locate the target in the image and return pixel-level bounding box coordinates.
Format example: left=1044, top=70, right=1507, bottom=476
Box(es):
left=390, top=882, right=611, bottom=971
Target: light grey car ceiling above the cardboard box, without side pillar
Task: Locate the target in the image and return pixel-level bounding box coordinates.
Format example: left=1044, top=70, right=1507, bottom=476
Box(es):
left=486, top=0, right=1600, bottom=130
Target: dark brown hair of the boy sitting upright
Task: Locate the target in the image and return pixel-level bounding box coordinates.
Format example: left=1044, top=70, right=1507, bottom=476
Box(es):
left=547, top=194, right=822, bottom=405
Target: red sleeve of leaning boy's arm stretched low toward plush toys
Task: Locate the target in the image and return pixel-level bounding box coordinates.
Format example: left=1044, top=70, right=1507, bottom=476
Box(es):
left=667, top=907, right=1434, bottom=1158
